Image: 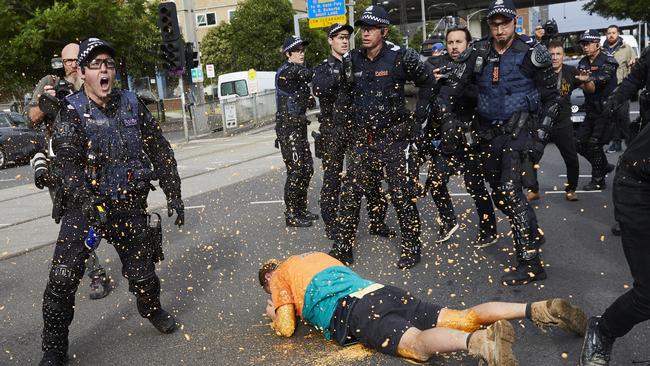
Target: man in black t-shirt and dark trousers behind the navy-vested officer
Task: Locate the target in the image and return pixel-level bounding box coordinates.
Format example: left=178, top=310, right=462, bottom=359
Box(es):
left=527, top=41, right=589, bottom=201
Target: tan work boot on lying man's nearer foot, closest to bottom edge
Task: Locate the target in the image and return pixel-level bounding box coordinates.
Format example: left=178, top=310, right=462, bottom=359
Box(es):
left=467, top=320, right=517, bottom=366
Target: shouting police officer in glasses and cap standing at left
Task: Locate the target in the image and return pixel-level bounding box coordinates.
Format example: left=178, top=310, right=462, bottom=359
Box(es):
left=40, top=38, right=185, bottom=365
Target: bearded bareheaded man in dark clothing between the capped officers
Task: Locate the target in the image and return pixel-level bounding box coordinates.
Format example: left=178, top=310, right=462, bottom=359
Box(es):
left=426, top=28, right=498, bottom=248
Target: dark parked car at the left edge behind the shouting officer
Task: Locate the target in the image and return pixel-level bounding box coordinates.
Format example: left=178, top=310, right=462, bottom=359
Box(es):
left=0, top=112, right=45, bottom=169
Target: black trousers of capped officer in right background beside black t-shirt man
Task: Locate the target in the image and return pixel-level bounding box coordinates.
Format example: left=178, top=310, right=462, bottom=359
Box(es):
left=576, top=112, right=612, bottom=180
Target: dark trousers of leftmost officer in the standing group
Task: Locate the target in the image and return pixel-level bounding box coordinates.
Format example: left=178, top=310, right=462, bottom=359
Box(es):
left=276, top=123, right=314, bottom=215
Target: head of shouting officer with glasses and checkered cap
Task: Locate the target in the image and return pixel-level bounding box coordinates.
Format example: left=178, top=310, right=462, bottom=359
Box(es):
left=79, top=38, right=116, bottom=106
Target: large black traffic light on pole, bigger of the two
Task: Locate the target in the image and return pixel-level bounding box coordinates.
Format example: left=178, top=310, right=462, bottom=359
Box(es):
left=158, top=2, right=185, bottom=70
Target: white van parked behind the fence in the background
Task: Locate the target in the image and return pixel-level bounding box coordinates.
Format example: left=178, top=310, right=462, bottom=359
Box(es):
left=217, top=71, right=275, bottom=100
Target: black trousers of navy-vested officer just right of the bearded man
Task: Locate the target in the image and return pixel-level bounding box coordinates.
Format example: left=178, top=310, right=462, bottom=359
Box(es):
left=481, top=131, right=539, bottom=261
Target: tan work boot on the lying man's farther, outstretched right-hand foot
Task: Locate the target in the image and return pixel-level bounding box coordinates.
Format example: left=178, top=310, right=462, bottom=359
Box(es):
left=530, top=299, right=587, bottom=337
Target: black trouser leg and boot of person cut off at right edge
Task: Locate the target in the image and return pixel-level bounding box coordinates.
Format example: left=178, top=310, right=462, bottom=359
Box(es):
left=599, top=162, right=650, bottom=337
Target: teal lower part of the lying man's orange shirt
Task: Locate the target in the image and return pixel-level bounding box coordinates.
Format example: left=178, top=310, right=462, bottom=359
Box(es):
left=302, top=266, right=374, bottom=340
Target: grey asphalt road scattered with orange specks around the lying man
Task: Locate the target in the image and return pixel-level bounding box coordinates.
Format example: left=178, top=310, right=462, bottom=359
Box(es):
left=0, top=130, right=650, bottom=366
